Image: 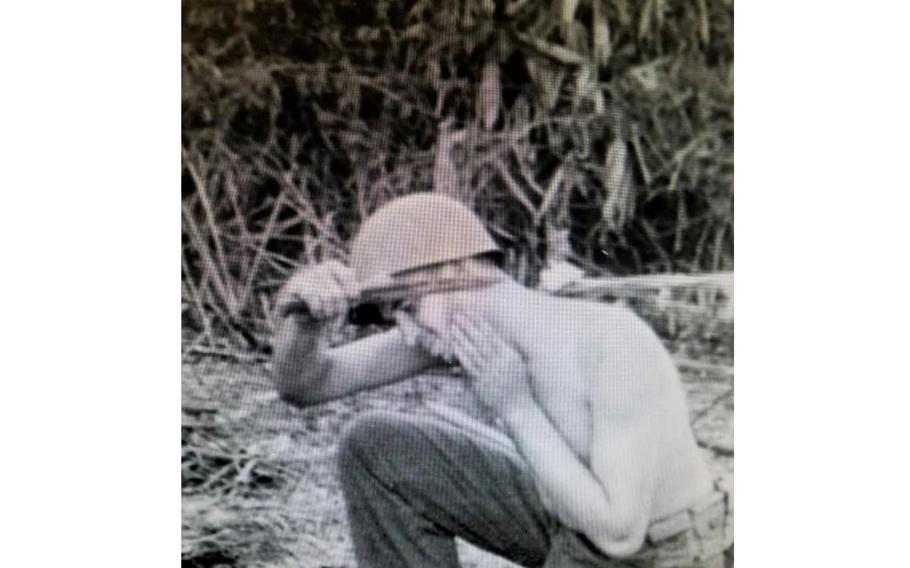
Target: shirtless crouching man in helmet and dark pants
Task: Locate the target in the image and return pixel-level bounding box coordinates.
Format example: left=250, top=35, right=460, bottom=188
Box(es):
left=274, top=194, right=725, bottom=568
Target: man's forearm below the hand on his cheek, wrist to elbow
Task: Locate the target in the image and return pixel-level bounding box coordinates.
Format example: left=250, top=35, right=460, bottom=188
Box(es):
left=503, top=403, right=641, bottom=556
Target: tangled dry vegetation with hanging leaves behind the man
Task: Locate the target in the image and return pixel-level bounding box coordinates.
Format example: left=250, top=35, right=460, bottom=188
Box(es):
left=182, top=0, right=733, bottom=349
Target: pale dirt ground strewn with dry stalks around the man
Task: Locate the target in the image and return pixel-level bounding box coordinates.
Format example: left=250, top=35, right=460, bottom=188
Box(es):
left=182, top=336, right=733, bottom=568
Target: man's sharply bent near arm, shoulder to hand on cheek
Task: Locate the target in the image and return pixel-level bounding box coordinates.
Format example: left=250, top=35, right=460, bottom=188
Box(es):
left=455, top=320, right=657, bottom=557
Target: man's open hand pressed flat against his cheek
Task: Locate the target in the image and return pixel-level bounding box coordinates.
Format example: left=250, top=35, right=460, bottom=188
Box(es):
left=452, top=315, right=534, bottom=416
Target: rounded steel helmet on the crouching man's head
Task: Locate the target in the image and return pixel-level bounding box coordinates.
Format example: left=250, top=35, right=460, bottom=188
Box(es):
left=351, top=193, right=499, bottom=286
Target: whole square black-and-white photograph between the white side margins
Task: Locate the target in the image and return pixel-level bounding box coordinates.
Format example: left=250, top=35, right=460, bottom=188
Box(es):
left=181, top=0, right=734, bottom=568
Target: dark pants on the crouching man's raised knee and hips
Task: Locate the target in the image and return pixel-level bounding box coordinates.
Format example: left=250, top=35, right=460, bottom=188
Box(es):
left=339, top=412, right=722, bottom=568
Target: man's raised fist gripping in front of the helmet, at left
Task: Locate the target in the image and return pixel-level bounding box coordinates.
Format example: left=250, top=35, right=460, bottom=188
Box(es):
left=275, top=260, right=360, bottom=320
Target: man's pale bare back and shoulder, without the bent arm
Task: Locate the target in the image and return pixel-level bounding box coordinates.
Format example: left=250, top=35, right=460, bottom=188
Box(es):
left=452, top=286, right=713, bottom=519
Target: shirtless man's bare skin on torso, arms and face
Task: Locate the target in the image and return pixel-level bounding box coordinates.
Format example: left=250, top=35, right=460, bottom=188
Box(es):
left=275, top=258, right=711, bottom=557
